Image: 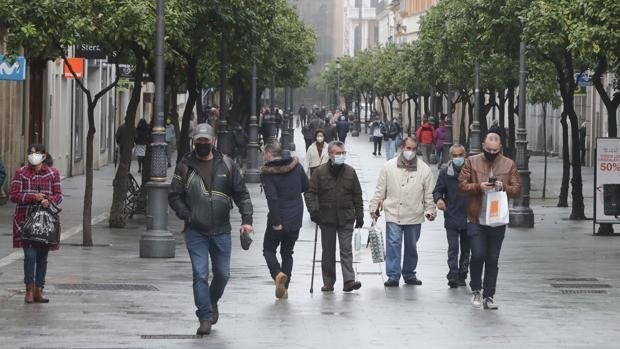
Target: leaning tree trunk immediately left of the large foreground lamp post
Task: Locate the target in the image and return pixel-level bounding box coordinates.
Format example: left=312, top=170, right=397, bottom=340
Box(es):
left=108, top=49, right=146, bottom=228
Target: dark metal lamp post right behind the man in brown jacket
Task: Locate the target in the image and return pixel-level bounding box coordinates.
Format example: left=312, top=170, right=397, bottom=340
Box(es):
left=509, top=42, right=534, bottom=228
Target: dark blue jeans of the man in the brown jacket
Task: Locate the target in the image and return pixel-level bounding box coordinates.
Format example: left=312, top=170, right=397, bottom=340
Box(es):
left=467, top=223, right=506, bottom=297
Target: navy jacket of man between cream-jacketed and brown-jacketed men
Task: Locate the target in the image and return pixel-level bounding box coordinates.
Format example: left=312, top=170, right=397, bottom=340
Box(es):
left=433, top=161, right=467, bottom=229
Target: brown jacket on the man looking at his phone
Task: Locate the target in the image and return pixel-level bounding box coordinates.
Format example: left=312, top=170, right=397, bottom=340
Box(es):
left=459, top=154, right=521, bottom=223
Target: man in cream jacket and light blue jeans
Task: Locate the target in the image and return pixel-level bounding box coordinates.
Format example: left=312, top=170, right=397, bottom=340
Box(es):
left=370, top=137, right=436, bottom=287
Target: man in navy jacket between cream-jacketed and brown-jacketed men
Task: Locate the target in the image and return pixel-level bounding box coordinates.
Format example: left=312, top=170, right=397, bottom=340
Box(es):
left=433, top=144, right=469, bottom=288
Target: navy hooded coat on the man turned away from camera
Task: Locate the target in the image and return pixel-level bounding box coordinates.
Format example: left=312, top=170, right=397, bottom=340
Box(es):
left=261, top=157, right=309, bottom=232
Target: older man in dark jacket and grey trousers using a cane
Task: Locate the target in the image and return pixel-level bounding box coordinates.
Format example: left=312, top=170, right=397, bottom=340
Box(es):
left=306, top=141, right=364, bottom=292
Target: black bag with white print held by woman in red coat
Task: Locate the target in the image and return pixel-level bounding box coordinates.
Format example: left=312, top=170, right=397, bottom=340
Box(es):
left=21, top=201, right=62, bottom=245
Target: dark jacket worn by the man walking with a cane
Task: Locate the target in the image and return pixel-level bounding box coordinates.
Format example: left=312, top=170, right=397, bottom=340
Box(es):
left=305, top=161, right=364, bottom=226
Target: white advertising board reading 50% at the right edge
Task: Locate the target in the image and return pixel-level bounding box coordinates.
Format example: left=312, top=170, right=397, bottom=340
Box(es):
left=594, top=138, right=620, bottom=224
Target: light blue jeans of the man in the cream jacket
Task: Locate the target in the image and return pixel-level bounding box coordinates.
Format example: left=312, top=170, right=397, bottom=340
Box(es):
left=385, top=222, right=422, bottom=281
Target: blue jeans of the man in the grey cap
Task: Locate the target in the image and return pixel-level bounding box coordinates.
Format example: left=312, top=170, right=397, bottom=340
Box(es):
left=185, top=228, right=231, bottom=321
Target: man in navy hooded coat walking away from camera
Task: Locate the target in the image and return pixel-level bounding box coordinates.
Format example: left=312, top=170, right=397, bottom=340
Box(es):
left=261, top=142, right=309, bottom=298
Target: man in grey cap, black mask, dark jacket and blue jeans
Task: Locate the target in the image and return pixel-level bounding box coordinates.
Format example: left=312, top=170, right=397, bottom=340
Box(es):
left=168, top=124, right=253, bottom=335
